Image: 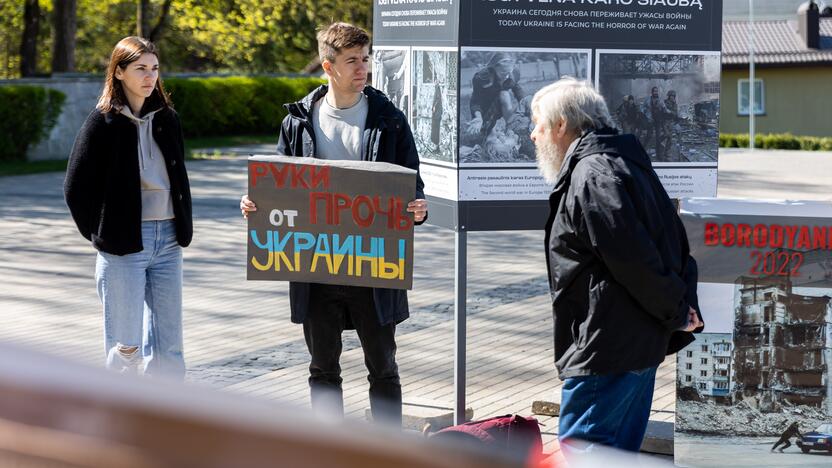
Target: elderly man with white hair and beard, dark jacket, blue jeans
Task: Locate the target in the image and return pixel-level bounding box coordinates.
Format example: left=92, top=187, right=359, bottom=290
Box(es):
left=531, top=78, right=704, bottom=456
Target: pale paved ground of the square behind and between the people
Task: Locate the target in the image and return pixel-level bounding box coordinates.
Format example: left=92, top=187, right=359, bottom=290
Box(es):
left=0, top=148, right=832, bottom=458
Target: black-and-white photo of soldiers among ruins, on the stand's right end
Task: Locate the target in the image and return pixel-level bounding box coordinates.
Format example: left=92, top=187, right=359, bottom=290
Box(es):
left=596, top=51, right=720, bottom=163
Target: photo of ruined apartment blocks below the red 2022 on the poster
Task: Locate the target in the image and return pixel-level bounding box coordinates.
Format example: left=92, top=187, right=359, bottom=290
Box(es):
left=675, top=280, right=832, bottom=467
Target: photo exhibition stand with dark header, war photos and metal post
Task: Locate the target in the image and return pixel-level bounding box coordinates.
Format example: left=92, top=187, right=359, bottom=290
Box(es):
left=372, top=0, right=722, bottom=423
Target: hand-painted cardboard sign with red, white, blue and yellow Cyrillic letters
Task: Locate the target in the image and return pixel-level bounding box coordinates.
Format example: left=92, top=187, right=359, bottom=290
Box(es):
left=246, top=156, right=416, bottom=289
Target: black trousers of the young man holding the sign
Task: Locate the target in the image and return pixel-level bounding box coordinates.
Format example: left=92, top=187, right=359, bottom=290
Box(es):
left=303, top=284, right=402, bottom=427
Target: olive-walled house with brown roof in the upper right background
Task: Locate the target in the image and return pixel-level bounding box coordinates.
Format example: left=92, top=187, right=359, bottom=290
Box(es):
left=719, top=0, right=832, bottom=137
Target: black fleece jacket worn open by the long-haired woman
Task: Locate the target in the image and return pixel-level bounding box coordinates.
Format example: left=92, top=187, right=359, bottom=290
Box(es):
left=64, top=91, right=193, bottom=255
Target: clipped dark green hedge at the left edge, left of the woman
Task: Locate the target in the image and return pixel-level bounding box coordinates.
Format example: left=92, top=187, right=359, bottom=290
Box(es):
left=0, top=85, right=66, bottom=161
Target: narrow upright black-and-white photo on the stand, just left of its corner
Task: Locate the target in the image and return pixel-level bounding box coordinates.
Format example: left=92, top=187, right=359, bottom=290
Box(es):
left=410, top=48, right=457, bottom=166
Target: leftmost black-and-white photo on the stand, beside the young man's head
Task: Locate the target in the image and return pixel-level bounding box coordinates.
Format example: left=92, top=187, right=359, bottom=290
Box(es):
left=373, top=46, right=410, bottom=119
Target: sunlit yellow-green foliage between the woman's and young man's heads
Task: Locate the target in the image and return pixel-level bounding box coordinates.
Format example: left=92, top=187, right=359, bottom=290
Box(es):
left=160, top=0, right=373, bottom=73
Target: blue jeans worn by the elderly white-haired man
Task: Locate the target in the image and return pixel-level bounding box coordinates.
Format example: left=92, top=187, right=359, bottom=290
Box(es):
left=558, top=367, right=656, bottom=454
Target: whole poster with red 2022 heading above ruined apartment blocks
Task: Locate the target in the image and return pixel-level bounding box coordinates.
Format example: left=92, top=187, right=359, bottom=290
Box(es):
left=675, top=198, right=832, bottom=467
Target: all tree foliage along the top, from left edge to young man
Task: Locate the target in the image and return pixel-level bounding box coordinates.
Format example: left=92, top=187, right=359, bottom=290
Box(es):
left=0, top=0, right=373, bottom=78
